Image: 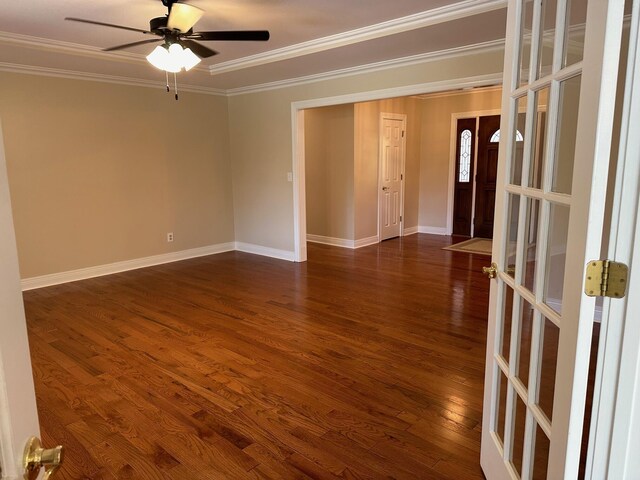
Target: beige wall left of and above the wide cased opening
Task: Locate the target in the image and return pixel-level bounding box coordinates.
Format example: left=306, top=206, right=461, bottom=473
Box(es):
left=229, top=51, right=503, bottom=252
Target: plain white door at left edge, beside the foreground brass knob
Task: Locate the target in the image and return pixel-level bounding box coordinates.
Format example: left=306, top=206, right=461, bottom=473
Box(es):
left=0, top=122, right=40, bottom=480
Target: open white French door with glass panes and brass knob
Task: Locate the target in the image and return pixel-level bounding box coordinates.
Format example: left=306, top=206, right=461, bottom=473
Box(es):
left=481, top=0, right=624, bottom=480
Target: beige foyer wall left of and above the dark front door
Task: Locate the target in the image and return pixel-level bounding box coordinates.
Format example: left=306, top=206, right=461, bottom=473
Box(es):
left=419, top=89, right=501, bottom=229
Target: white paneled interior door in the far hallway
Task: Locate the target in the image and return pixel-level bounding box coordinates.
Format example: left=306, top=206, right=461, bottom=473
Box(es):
left=378, top=113, right=407, bottom=241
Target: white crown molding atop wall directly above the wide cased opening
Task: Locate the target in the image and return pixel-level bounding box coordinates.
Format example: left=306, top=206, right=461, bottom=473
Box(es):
left=226, top=39, right=504, bottom=96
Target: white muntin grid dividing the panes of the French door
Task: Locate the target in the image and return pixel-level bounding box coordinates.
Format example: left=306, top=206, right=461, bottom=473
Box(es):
left=491, top=0, right=582, bottom=479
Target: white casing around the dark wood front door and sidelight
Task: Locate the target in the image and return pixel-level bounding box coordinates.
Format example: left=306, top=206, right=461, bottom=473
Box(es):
left=446, top=109, right=502, bottom=237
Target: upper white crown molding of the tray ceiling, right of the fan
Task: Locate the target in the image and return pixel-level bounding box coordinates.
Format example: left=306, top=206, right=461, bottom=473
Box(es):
left=209, top=0, right=507, bottom=75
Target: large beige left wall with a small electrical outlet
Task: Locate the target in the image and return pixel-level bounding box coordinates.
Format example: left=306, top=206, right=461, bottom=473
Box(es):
left=0, top=73, right=234, bottom=278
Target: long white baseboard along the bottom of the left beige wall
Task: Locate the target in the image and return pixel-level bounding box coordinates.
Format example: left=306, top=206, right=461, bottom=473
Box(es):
left=20, top=242, right=235, bottom=291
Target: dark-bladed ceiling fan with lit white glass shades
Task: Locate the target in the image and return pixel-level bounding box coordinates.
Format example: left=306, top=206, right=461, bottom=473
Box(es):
left=65, top=0, right=269, bottom=100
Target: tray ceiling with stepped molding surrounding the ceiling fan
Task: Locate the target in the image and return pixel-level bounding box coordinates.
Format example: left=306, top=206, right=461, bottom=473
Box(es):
left=0, top=0, right=506, bottom=91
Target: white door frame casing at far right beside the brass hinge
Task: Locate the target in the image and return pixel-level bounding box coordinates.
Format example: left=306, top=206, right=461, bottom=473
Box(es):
left=585, top=3, right=640, bottom=480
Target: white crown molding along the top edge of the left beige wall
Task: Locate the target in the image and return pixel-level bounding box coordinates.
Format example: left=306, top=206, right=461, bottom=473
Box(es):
left=0, top=62, right=227, bottom=96
